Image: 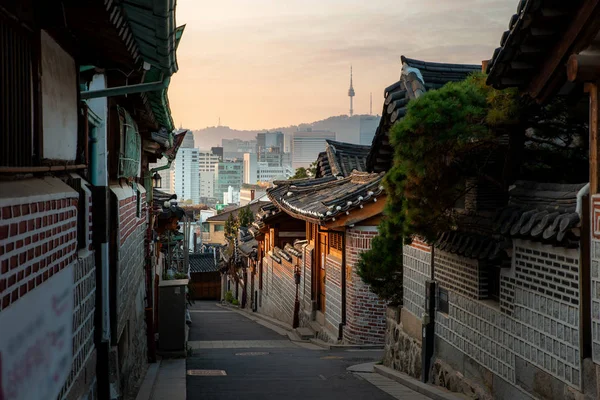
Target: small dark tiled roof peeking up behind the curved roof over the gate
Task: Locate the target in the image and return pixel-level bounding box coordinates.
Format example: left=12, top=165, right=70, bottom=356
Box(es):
left=316, top=140, right=371, bottom=178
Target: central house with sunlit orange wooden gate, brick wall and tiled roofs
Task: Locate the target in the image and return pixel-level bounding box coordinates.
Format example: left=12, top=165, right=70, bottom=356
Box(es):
left=259, top=57, right=480, bottom=343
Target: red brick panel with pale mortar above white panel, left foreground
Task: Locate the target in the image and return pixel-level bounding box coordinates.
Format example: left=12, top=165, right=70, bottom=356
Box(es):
left=0, top=178, right=79, bottom=310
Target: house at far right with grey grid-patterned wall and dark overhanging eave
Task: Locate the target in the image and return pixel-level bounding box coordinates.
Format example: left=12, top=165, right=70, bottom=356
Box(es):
left=384, top=0, right=600, bottom=399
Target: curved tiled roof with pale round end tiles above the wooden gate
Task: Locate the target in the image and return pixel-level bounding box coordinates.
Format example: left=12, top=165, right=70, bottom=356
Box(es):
left=267, top=171, right=383, bottom=221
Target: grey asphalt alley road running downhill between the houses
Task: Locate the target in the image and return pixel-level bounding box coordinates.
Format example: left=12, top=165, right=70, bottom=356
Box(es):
left=187, top=302, right=423, bottom=400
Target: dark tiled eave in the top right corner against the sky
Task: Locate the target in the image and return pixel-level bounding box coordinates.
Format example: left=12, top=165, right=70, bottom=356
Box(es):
left=487, top=0, right=600, bottom=96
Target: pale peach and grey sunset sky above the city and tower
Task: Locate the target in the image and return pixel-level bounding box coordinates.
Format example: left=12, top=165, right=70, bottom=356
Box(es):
left=169, top=0, right=518, bottom=129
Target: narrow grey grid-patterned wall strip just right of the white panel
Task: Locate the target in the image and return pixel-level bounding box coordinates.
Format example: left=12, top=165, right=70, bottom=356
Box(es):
left=58, top=251, right=96, bottom=399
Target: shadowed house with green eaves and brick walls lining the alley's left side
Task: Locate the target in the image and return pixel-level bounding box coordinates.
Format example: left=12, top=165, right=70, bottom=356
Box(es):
left=0, top=0, right=184, bottom=399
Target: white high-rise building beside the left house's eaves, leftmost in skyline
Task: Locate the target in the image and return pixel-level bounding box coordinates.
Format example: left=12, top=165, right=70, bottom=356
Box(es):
left=173, top=148, right=200, bottom=204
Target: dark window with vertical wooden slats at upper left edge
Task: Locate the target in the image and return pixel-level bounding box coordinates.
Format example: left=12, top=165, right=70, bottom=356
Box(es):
left=0, top=9, right=40, bottom=167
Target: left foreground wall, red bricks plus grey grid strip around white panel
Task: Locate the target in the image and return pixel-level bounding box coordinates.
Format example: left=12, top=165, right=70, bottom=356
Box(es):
left=0, top=178, right=96, bottom=399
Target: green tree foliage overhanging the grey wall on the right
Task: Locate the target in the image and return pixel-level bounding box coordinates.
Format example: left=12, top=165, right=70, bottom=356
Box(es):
left=358, top=74, right=588, bottom=302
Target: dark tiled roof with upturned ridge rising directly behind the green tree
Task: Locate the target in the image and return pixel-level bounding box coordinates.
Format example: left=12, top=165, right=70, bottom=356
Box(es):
left=366, top=56, right=481, bottom=172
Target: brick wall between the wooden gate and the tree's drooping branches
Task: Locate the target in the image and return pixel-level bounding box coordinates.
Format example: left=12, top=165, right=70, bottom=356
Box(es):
left=344, top=227, right=386, bottom=344
